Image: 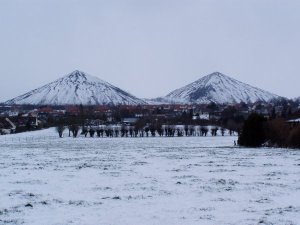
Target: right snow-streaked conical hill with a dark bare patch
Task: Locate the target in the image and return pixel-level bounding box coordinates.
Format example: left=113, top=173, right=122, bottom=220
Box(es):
left=161, top=72, right=279, bottom=104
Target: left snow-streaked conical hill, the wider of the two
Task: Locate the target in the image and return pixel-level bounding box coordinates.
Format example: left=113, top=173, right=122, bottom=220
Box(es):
left=5, top=70, right=145, bottom=105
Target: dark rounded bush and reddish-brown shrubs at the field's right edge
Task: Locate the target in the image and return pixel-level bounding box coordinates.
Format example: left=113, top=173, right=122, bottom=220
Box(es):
left=238, top=114, right=300, bottom=148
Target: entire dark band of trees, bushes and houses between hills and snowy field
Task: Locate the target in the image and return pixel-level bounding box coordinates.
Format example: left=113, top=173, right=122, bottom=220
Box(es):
left=0, top=99, right=300, bottom=148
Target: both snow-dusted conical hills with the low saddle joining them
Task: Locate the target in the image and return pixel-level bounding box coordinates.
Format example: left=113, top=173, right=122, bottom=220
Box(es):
left=4, top=70, right=279, bottom=105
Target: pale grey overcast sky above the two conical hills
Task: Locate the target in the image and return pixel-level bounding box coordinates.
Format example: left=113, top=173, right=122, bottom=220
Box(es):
left=0, top=0, right=300, bottom=101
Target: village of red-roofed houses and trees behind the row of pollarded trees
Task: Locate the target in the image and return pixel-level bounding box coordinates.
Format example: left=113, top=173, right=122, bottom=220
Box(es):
left=0, top=99, right=300, bottom=135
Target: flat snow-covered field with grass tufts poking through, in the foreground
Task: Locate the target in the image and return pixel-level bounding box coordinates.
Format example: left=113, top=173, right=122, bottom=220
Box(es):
left=0, top=129, right=300, bottom=225
